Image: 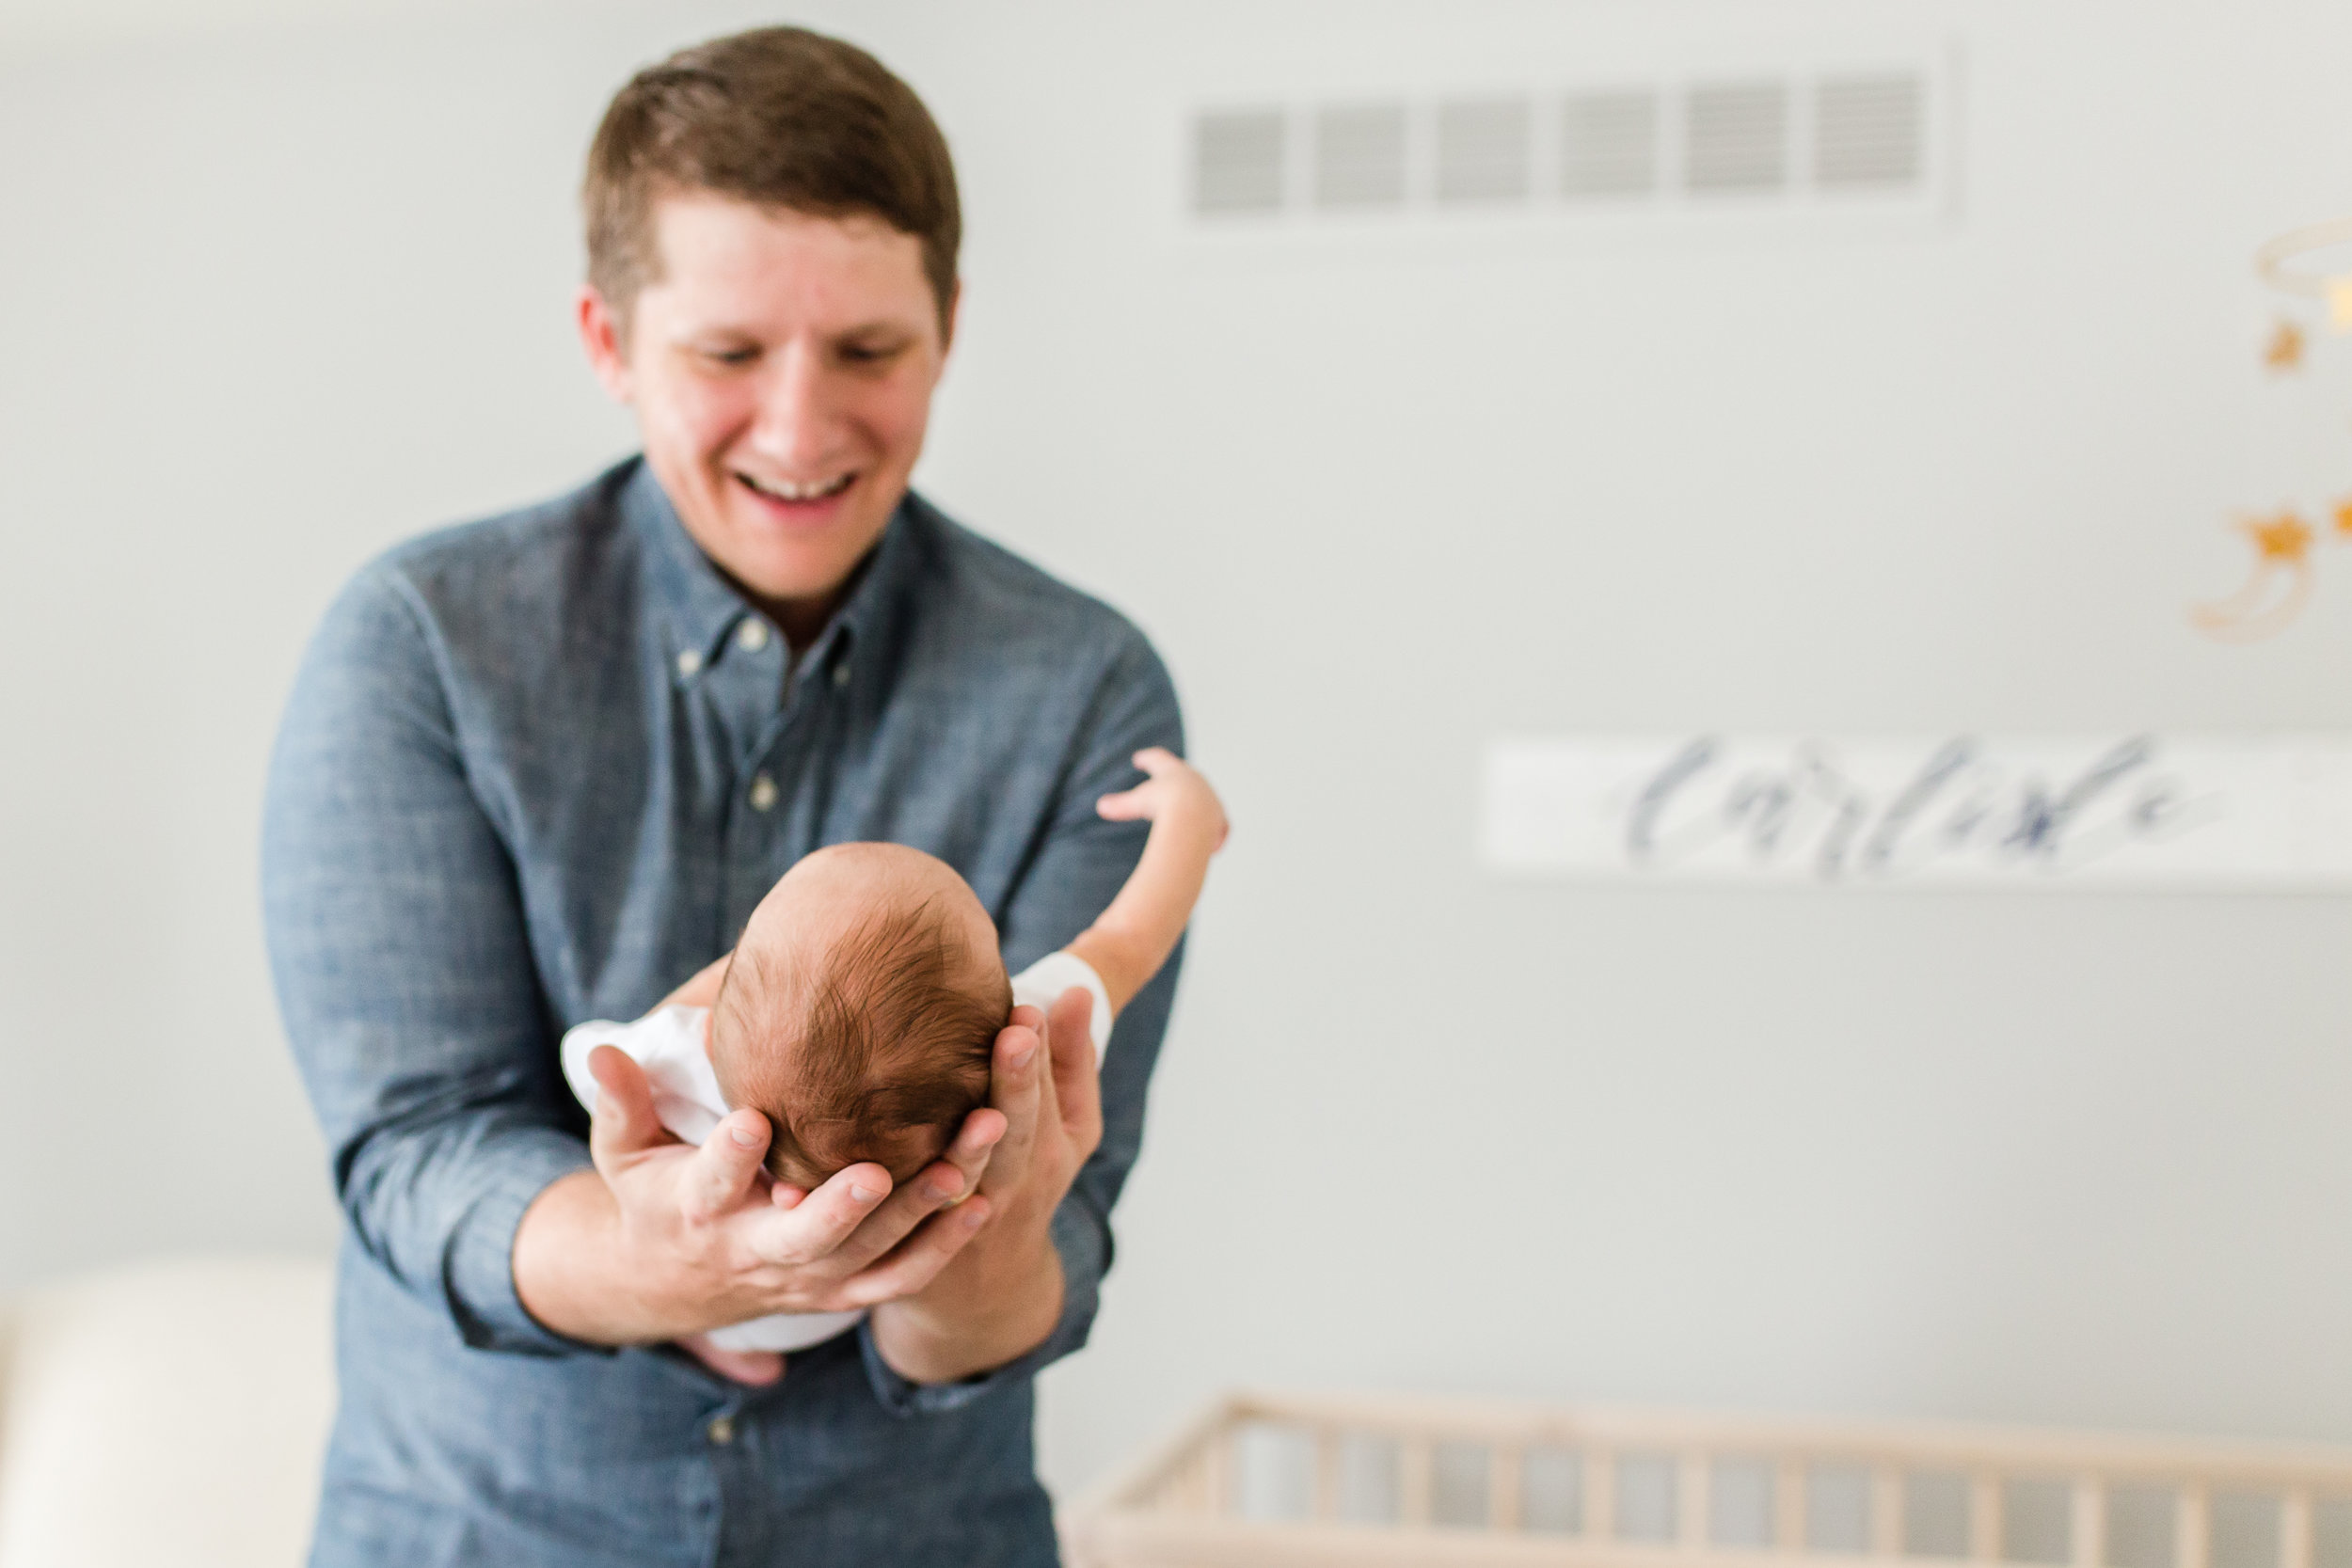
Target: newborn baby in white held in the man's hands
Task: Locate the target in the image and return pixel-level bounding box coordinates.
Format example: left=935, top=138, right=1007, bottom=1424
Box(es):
left=563, top=748, right=1226, bottom=1350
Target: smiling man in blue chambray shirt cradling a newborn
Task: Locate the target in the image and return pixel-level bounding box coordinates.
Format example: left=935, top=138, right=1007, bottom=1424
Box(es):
left=263, top=28, right=1181, bottom=1568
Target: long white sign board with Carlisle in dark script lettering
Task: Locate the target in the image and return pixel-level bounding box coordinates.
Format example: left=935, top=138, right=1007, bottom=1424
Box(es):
left=1480, top=734, right=2352, bottom=889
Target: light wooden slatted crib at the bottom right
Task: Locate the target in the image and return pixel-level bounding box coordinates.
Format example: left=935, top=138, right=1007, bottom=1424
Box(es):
left=1061, top=1394, right=2352, bottom=1568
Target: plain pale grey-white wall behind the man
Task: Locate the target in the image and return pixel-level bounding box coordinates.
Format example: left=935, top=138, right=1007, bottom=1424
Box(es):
left=0, top=0, right=2352, bottom=1486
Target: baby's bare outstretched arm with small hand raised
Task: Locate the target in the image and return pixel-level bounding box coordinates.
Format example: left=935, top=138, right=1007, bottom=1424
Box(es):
left=1068, top=745, right=1226, bottom=1013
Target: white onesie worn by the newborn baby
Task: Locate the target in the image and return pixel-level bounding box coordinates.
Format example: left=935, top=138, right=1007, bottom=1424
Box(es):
left=563, top=952, right=1110, bottom=1350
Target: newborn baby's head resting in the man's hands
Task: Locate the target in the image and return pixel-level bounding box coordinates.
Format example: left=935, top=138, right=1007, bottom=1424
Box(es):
left=710, top=844, right=1014, bottom=1190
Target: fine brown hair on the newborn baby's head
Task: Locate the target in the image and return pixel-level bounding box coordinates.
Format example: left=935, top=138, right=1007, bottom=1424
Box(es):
left=710, top=900, right=1014, bottom=1187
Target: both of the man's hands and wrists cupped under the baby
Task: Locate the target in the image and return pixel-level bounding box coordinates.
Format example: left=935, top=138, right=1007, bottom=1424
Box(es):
left=516, top=973, right=1104, bottom=1383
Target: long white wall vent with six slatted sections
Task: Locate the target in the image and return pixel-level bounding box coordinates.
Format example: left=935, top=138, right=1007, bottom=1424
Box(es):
left=1188, top=49, right=1955, bottom=235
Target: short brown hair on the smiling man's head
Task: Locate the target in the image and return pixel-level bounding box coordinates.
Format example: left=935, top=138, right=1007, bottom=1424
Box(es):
left=581, top=28, right=964, bottom=336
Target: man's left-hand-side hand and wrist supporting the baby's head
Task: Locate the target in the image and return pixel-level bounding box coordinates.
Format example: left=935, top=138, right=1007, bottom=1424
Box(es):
left=516, top=1046, right=1007, bottom=1380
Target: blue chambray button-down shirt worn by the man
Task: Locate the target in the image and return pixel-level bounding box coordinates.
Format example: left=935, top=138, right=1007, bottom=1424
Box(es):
left=262, top=461, right=1184, bottom=1568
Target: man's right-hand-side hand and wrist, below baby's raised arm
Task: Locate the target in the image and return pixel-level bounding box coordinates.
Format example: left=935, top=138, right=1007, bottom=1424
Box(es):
left=873, top=990, right=1104, bottom=1383
